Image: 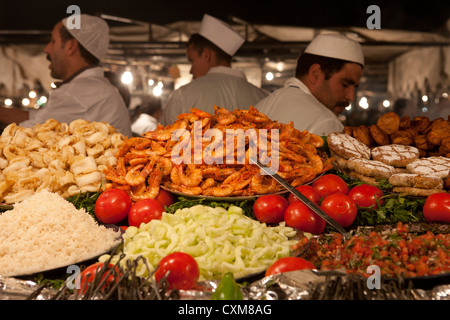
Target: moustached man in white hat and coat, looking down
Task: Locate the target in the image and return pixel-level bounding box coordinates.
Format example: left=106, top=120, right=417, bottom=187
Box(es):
left=255, top=34, right=364, bottom=136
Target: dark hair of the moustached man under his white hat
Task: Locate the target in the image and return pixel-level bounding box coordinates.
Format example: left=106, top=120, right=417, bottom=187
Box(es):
left=295, top=53, right=362, bottom=80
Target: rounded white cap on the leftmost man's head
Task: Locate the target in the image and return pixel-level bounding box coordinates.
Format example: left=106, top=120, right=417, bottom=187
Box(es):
left=62, top=13, right=109, bottom=60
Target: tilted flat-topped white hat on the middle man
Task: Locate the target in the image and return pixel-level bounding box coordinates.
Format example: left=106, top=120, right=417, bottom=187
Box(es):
left=198, top=14, right=245, bottom=56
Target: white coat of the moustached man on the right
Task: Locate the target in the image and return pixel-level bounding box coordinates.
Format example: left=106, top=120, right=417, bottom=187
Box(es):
left=255, top=78, right=344, bottom=136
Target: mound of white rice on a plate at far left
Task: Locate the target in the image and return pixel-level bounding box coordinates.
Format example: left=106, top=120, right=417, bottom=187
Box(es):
left=0, top=190, right=120, bottom=276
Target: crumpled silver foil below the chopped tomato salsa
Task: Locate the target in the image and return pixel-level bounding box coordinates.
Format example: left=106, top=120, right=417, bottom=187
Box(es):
left=243, top=270, right=450, bottom=300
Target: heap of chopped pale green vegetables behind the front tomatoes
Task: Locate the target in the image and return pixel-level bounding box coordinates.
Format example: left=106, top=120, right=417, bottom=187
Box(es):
left=100, top=205, right=297, bottom=281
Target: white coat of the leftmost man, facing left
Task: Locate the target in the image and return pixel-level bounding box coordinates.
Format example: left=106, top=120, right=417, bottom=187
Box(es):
left=20, top=67, right=131, bottom=137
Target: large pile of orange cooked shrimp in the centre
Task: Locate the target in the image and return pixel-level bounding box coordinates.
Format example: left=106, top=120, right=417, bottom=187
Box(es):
left=104, top=106, right=332, bottom=201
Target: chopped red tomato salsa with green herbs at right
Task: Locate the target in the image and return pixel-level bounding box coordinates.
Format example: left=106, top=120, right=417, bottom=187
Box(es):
left=305, top=223, right=450, bottom=278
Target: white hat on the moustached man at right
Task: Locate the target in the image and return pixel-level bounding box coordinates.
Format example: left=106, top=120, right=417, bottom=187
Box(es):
left=305, top=34, right=364, bottom=65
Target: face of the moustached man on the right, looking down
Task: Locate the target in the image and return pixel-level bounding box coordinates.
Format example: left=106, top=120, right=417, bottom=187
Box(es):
left=311, top=63, right=363, bottom=115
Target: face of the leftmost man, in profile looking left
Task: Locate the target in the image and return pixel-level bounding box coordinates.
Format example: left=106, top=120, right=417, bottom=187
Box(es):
left=44, top=22, right=69, bottom=80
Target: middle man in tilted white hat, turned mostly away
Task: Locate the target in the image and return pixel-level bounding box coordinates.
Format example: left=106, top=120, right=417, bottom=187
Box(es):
left=161, top=14, right=267, bottom=125
